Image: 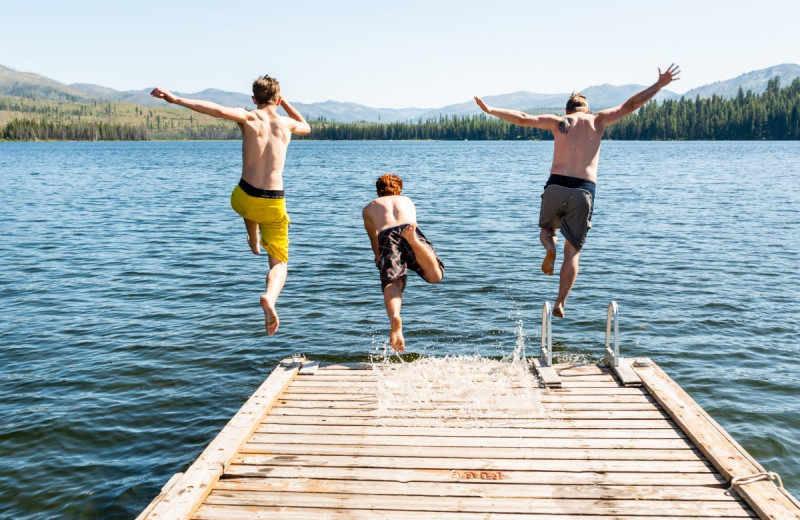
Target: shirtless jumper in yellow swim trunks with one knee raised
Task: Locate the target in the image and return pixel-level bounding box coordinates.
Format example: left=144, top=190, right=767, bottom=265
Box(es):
left=150, top=75, right=311, bottom=334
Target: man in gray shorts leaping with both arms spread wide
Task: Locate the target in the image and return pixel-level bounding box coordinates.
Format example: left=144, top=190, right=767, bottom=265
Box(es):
left=475, top=64, right=680, bottom=318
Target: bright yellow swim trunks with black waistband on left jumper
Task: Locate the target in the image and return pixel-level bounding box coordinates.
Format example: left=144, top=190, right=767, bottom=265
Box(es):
left=231, top=180, right=289, bottom=262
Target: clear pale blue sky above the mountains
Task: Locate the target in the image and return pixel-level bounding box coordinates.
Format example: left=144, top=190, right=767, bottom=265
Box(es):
left=0, top=0, right=800, bottom=108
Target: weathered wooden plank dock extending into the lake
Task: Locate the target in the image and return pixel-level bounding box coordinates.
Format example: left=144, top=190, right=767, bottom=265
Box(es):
left=139, top=359, right=800, bottom=520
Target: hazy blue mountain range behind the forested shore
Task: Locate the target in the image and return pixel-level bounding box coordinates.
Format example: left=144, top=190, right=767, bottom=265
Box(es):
left=0, top=63, right=800, bottom=123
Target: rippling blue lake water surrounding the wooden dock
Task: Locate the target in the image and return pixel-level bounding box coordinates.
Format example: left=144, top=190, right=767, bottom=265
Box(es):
left=0, top=142, right=800, bottom=519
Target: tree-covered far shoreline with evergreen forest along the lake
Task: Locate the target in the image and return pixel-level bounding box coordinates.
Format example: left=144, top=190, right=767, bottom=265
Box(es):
left=0, top=78, right=800, bottom=141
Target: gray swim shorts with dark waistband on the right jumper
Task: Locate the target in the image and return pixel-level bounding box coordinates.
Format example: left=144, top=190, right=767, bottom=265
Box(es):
left=539, top=184, right=592, bottom=251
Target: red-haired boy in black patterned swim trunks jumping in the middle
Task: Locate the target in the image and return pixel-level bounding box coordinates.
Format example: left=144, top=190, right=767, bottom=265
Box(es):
left=361, top=173, right=444, bottom=352
